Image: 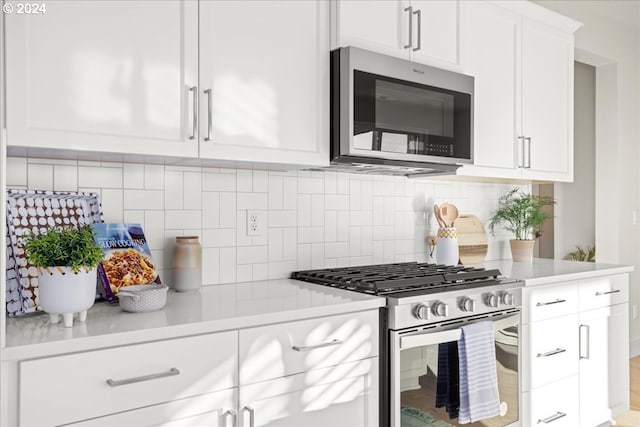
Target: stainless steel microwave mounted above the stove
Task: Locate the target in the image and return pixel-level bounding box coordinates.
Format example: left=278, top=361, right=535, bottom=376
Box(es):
left=331, top=47, right=474, bottom=175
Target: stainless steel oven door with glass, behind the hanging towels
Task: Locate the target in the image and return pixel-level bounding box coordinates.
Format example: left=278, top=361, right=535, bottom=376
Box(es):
left=389, top=310, right=521, bottom=427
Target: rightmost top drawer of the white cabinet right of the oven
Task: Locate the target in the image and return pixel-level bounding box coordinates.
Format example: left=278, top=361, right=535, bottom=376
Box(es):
left=579, top=274, right=629, bottom=311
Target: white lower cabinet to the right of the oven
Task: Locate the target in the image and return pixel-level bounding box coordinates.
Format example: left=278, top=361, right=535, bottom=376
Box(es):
left=522, top=274, right=629, bottom=427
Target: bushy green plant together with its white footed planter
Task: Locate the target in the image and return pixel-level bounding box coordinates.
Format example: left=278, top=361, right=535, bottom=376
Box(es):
left=23, top=225, right=103, bottom=327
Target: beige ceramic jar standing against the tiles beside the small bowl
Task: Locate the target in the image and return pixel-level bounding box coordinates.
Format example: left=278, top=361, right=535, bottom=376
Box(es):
left=172, top=236, right=202, bottom=292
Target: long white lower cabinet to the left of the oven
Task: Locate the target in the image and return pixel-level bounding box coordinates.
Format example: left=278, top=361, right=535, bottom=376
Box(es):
left=8, top=309, right=379, bottom=427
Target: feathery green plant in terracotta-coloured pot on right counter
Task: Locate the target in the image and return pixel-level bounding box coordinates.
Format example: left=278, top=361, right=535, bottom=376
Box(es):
left=489, top=187, right=555, bottom=261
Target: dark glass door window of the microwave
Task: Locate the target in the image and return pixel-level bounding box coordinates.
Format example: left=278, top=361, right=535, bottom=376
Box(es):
left=353, top=70, right=471, bottom=160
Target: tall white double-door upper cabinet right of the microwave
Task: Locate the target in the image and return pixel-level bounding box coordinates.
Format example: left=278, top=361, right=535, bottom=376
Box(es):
left=458, top=1, right=579, bottom=181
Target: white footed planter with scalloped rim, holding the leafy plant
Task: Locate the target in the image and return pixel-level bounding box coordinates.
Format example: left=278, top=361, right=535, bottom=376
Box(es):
left=38, top=267, right=96, bottom=328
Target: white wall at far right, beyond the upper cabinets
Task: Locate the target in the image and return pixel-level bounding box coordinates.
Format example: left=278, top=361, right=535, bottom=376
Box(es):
left=536, top=0, right=640, bottom=355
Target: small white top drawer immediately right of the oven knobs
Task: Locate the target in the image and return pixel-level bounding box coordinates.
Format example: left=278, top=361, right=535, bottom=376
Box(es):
left=522, top=282, right=578, bottom=323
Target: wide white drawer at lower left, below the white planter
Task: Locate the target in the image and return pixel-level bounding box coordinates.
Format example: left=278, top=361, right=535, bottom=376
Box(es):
left=19, top=331, right=238, bottom=427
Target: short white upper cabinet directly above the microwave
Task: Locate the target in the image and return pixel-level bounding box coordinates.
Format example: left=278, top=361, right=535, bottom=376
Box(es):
left=332, top=0, right=459, bottom=68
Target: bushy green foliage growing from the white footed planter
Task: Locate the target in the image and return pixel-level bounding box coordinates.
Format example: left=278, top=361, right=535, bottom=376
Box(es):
left=23, top=225, right=104, bottom=272
